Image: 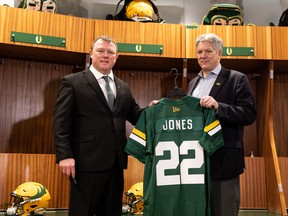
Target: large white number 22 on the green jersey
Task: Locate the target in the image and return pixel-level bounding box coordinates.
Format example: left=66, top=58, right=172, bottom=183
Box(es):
left=155, top=141, right=205, bottom=186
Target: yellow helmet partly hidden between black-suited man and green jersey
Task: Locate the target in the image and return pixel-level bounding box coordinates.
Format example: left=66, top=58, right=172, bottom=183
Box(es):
left=122, top=182, right=144, bottom=214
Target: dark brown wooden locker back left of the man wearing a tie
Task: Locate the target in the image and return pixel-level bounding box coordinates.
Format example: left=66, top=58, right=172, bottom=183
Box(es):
left=0, top=59, right=72, bottom=153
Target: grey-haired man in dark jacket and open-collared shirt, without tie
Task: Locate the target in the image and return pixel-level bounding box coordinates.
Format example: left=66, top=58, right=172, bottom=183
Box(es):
left=187, top=34, right=256, bottom=216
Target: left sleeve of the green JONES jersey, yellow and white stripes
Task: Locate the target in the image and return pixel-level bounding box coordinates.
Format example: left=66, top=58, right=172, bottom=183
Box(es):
left=125, top=110, right=147, bottom=163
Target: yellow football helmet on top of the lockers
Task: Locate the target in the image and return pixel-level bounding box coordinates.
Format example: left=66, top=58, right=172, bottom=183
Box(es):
left=126, top=0, right=154, bottom=22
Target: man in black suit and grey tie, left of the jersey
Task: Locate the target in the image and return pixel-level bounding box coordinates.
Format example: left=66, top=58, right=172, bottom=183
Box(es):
left=54, top=36, right=142, bottom=216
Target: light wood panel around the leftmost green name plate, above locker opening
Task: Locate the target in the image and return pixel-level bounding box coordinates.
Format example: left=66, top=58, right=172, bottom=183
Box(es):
left=0, top=6, right=86, bottom=52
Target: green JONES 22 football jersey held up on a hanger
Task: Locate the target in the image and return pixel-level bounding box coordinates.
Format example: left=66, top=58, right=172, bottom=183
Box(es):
left=125, top=96, right=224, bottom=216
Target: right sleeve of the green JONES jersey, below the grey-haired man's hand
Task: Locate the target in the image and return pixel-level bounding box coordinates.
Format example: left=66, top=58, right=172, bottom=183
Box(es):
left=199, top=109, right=224, bottom=155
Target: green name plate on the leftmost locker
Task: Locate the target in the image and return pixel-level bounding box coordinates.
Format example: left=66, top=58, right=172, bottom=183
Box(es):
left=10, top=32, right=66, bottom=47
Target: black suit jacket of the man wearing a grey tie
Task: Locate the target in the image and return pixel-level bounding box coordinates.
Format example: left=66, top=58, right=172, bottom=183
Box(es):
left=53, top=69, right=142, bottom=172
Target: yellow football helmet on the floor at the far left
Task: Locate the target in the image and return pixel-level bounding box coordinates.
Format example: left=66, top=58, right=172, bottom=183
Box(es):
left=5, top=182, right=50, bottom=216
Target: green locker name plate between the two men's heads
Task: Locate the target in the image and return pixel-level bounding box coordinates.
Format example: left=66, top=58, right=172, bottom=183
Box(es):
left=117, top=43, right=163, bottom=54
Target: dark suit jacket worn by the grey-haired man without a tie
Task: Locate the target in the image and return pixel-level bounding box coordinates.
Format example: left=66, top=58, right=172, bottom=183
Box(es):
left=187, top=67, right=256, bottom=179
